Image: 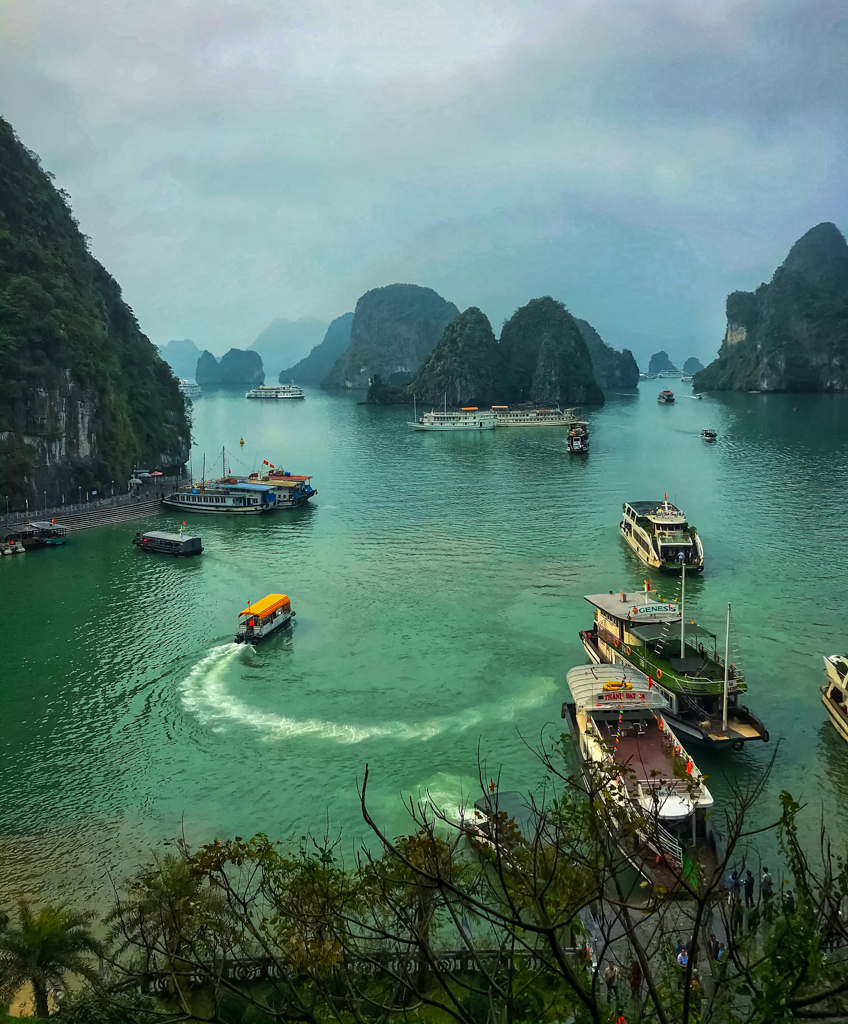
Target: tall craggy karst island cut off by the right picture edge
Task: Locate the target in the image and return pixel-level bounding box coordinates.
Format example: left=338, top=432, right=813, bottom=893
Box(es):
left=694, top=223, right=848, bottom=391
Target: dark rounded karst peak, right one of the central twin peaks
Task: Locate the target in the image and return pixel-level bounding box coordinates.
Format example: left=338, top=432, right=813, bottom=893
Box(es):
left=501, top=295, right=604, bottom=407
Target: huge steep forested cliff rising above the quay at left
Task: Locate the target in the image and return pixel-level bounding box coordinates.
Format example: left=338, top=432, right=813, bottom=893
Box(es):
left=0, top=119, right=189, bottom=509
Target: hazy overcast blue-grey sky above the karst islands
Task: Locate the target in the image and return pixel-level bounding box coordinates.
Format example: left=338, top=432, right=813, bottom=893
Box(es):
left=0, top=0, right=848, bottom=365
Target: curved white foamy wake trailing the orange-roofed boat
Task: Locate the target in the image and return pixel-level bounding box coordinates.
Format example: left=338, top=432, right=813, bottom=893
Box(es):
left=180, top=644, right=556, bottom=743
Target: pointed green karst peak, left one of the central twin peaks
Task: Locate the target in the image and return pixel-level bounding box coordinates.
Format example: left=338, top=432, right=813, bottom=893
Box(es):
left=407, top=306, right=503, bottom=406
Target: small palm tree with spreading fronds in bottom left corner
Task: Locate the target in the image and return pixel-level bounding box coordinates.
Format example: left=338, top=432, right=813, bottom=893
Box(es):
left=0, top=900, right=102, bottom=1018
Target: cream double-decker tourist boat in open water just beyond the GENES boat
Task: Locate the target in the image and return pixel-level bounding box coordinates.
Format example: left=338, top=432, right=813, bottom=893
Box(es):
left=619, top=495, right=704, bottom=572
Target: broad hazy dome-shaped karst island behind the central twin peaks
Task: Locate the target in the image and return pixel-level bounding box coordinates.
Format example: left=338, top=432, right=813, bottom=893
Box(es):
left=322, top=285, right=459, bottom=388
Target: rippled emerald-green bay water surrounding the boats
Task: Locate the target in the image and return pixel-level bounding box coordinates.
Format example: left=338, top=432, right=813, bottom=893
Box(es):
left=0, top=382, right=848, bottom=898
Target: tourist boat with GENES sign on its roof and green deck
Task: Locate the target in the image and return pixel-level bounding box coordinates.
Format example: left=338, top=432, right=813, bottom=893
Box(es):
left=580, top=577, right=769, bottom=751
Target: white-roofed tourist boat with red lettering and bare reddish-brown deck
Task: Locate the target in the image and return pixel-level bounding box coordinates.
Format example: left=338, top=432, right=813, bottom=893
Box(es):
left=562, top=665, right=717, bottom=888
